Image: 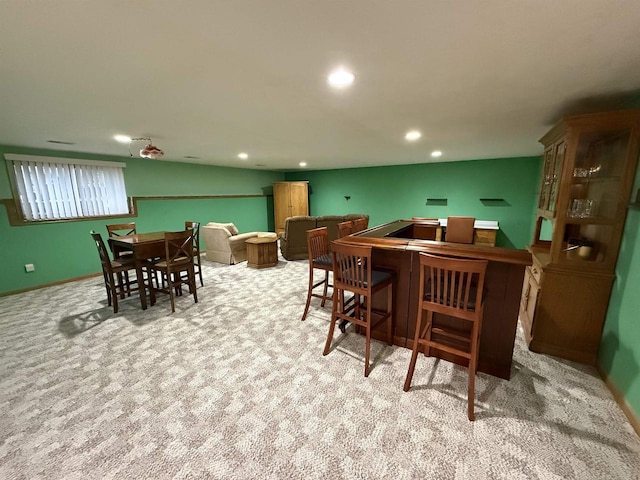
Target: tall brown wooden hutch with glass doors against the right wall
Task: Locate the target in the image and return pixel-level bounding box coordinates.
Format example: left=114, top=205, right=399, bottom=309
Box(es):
left=520, top=110, right=640, bottom=364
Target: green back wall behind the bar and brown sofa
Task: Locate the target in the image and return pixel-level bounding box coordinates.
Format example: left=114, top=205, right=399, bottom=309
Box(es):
left=286, top=157, right=541, bottom=248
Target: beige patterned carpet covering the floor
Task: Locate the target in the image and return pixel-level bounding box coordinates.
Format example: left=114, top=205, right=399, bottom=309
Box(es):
left=0, top=253, right=640, bottom=480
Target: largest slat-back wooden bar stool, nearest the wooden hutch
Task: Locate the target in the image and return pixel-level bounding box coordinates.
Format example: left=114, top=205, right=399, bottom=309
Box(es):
left=404, top=253, right=489, bottom=421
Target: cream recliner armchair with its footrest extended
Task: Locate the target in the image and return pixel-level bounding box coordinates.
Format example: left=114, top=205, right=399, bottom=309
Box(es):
left=200, top=222, right=276, bottom=265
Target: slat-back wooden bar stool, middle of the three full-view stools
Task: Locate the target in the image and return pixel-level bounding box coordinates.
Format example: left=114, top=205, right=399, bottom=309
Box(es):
left=322, top=242, right=395, bottom=377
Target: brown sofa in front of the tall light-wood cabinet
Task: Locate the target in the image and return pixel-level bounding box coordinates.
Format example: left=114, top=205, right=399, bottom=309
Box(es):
left=280, top=213, right=369, bottom=260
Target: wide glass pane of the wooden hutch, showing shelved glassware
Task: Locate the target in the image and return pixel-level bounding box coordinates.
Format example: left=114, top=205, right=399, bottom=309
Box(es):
left=559, top=129, right=631, bottom=264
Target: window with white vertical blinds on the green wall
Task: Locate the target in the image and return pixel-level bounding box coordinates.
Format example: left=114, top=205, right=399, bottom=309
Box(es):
left=4, top=154, right=129, bottom=221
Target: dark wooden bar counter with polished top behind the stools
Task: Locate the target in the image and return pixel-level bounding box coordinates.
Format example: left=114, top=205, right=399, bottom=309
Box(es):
left=339, top=220, right=532, bottom=379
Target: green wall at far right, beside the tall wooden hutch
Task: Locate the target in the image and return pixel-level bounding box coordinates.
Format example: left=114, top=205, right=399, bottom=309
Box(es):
left=598, top=95, right=640, bottom=417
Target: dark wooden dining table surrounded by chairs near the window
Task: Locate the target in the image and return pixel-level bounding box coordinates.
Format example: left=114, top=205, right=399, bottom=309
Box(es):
left=109, top=231, right=165, bottom=310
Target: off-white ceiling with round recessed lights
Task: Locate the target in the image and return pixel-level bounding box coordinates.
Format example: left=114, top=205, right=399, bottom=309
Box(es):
left=0, top=0, right=640, bottom=170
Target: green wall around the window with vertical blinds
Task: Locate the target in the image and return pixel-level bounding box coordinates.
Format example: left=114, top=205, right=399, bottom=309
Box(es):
left=0, top=146, right=284, bottom=294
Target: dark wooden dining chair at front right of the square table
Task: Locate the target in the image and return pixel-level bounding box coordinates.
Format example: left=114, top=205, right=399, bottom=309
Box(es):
left=145, top=230, right=198, bottom=313
